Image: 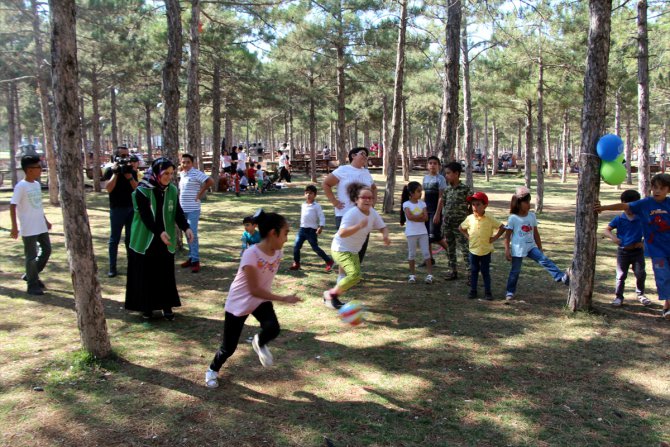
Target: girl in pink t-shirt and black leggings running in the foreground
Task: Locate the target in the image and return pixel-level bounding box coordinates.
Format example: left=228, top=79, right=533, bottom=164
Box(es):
left=205, top=210, right=300, bottom=388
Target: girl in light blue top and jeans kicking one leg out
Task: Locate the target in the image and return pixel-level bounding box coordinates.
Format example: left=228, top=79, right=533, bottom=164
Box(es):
left=505, top=186, right=570, bottom=300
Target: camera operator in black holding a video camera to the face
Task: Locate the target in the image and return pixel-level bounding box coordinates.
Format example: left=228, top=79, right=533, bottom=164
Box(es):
left=103, top=146, right=138, bottom=278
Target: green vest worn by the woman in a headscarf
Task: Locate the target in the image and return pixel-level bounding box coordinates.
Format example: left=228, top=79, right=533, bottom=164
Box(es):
left=130, top=183, right=178, bottom=255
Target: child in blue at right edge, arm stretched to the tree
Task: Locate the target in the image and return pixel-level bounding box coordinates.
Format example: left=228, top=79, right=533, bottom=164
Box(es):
left=595, top=174, right=670, bottom=320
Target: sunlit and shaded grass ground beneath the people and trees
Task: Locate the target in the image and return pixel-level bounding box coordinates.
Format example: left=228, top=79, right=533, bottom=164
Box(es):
left=0, top=170, right=670, bottom=447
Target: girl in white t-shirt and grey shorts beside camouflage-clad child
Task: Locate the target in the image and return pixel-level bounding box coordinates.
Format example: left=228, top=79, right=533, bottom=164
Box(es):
left=400, top=182, right=433, bottom=284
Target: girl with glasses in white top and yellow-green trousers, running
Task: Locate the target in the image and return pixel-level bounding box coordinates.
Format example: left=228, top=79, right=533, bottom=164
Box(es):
left=323, top=182, right=391, bottom=309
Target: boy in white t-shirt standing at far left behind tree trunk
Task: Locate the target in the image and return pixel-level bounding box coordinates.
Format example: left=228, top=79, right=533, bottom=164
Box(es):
left=9, top=155, right=51, bottom=295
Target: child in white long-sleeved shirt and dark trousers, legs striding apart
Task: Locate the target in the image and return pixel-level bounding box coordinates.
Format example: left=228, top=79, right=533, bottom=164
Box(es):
left=290, top=185, right=334, bottom=272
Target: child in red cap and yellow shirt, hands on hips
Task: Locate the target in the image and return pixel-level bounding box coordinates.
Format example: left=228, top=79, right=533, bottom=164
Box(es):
left=458, top=192, right=505, bottom=301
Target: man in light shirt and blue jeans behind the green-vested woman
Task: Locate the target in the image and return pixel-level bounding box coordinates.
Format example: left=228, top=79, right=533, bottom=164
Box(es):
left=179, top=154, right=214, bottom=273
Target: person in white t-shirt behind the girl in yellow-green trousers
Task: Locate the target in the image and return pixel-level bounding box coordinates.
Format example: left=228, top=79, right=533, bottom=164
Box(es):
left=323, top=147, right=377, bottom=263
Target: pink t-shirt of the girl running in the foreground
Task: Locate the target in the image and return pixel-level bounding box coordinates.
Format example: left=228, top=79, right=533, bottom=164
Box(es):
left=225, top=245, right=282, bottom=317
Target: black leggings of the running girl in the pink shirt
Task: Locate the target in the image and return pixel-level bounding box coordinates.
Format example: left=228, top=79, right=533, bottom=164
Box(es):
left=209, top=301, right=279, bottom=371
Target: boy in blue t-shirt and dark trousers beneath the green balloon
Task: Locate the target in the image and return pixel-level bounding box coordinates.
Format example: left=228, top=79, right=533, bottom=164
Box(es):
left=604, top=189, right=651, bottom=307
